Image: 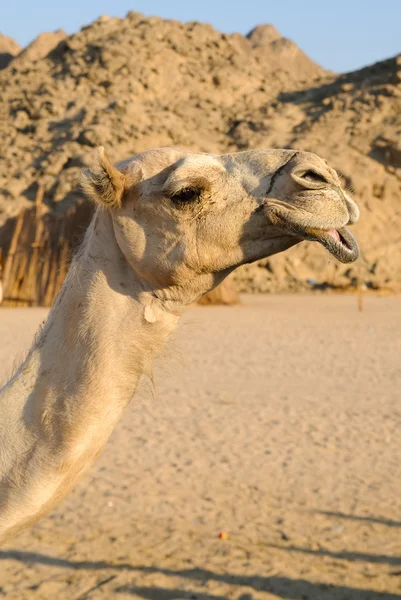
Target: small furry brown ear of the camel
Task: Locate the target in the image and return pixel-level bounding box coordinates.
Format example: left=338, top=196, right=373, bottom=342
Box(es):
left=81, top=146, right=125, bottom=208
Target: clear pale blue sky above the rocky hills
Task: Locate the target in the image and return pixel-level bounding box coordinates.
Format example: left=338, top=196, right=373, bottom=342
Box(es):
left=0, top=0, right=401, bottom=72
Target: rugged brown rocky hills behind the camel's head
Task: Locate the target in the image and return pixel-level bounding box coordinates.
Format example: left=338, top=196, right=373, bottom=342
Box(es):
left=0, top=12, right=401, bottom=291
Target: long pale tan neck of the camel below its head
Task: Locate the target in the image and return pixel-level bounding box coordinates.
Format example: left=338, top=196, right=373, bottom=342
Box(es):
left=0, top=214, right=178, bottom=538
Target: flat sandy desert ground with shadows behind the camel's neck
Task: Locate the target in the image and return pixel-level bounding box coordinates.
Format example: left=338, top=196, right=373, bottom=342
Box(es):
left=0, top=296, right=401, bottom=600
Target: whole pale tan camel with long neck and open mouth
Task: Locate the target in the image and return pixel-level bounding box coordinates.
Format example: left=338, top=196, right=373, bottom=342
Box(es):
left=0, top=148, right=359, bottom=541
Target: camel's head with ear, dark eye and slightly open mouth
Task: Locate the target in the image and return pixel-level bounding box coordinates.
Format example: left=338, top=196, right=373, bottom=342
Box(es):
left=83, top=148, right=359, bottom=301
